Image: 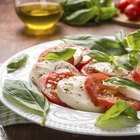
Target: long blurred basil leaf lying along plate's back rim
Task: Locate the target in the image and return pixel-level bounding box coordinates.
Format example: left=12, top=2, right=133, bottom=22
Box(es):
left=61, top=35, right=128, bottom=55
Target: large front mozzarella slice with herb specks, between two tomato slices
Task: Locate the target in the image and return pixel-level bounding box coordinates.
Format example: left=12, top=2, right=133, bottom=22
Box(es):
left=57, top=76, right=103, bottom=112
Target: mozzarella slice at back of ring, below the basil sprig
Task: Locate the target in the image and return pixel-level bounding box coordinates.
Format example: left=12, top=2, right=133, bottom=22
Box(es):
left=89, top=62, right=127, bottom=76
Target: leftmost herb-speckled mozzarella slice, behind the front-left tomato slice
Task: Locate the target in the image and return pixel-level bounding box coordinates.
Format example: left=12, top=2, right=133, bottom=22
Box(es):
left=30, top=61, right=80, bottom=83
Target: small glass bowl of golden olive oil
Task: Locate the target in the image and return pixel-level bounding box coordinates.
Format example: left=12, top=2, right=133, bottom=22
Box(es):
left=16, top=2, right=63, bottom=30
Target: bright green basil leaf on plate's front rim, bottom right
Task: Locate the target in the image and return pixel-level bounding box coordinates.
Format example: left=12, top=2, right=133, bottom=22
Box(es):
left=95, top=100, right=140, bottom=129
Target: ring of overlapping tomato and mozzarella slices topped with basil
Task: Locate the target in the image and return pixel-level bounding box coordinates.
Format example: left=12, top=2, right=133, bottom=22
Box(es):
left=31, top=33, right=140, bottom=112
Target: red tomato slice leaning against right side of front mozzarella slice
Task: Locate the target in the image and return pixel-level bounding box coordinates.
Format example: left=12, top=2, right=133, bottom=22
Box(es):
left=85, top=73, right=108, bottom=106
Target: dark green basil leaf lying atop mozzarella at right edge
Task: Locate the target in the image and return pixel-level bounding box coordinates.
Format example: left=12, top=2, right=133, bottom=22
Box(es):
left=103, top=77, right=140, bottom=90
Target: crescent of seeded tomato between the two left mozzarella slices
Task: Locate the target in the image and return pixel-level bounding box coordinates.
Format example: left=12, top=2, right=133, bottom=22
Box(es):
left=38, top=72, right=74, bottom=106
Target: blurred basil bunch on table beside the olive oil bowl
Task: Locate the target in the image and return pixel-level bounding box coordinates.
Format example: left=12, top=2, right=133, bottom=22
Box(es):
left=60, top=0, right=117, bottom=25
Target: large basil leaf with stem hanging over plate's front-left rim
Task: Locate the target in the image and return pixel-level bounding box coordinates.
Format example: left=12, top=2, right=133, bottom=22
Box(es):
left=3, top=79, right=49, bottom=125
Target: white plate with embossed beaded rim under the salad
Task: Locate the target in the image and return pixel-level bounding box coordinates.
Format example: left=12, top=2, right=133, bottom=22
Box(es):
left=0, top=40, right=140, bottom=136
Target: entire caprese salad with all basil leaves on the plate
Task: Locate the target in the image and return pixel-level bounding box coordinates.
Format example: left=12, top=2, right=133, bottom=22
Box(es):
left=3, top=30, right=140, bottom=129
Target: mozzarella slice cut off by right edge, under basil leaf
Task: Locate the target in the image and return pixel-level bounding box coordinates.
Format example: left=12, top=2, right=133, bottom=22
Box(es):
left=118, top=87, right=140, bottom=101
